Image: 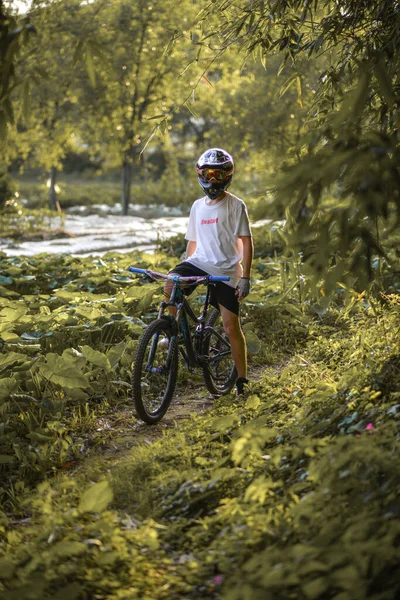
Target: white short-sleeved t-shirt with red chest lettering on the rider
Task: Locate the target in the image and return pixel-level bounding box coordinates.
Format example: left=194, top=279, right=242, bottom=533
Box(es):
left=185, top=192, right=251, bottom=287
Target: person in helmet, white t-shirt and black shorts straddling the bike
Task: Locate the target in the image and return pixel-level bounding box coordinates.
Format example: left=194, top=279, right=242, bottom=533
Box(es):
left=165, top=148, right=253, bottom=394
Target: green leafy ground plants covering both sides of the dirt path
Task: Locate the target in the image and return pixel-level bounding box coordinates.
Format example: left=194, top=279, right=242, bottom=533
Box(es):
left=0, top=238, right=400, bottom=600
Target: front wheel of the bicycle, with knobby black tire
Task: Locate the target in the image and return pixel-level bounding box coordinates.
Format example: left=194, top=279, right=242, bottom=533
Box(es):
left=132, top=319, right=178, bottom=425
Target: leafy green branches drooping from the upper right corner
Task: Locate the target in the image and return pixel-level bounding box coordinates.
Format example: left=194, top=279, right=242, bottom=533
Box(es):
left=199, top=0, right=400, bottom=286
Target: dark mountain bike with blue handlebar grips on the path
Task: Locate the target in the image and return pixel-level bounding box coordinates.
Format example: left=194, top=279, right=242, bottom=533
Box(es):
left=128, top=267, right=237, bottom=424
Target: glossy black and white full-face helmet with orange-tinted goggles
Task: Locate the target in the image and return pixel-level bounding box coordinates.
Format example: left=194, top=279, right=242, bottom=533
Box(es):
left=196, top=148, right=235, bottom=200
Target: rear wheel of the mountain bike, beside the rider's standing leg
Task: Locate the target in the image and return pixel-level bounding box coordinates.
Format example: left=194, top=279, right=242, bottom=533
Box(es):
left=202, top=308, right=237, bottom=396
